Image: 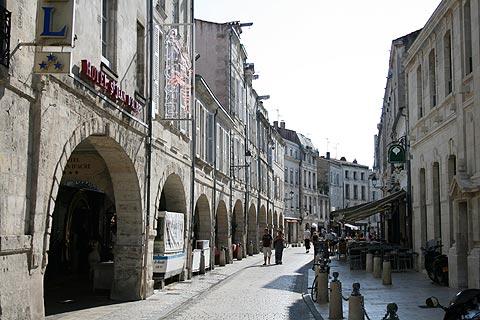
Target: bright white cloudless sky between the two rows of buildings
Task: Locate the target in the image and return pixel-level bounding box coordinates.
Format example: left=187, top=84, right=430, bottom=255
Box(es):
left=195, top=0, right=440, bottom=167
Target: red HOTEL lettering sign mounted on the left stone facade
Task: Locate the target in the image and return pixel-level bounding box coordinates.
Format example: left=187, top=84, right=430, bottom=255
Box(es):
left=80, top=59, right=142, bottom=114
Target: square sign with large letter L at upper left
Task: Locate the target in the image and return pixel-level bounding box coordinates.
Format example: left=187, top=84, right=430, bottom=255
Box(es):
left=35, top=0, right=75, bottom=46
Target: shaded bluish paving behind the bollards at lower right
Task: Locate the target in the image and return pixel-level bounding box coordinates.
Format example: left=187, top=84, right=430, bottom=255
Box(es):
left=308, top=259, right=458, bottom=320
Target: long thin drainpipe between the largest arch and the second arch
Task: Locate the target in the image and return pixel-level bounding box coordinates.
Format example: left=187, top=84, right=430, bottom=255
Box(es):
left=140, top=0, right=153, bottom=299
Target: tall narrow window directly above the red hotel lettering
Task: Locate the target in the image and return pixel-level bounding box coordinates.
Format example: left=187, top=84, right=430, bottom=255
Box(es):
left=102, top=0, right=116, bottom=68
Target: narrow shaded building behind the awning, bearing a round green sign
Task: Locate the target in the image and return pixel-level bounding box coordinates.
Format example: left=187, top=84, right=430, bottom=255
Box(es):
left=372, top=30, right=420, bottom=247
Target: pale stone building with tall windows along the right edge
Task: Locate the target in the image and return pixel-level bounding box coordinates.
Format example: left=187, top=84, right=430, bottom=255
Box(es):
left=405, top=0, right=480, bottom=288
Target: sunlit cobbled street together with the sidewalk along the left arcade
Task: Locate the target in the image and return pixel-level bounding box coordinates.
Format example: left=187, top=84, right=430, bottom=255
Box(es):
left=46, top=248, right=313, bottom=320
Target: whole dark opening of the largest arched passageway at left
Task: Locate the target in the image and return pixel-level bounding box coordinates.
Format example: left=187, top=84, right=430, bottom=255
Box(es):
left=44, top=135, right=143, bottom=315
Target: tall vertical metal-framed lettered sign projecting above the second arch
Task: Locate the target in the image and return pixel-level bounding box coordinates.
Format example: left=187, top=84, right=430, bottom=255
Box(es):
left=165, top=28, right=192, bottom=119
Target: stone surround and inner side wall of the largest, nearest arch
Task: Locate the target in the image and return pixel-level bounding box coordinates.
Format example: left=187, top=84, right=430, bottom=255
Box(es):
left=42, top=134, right=145, bottom=300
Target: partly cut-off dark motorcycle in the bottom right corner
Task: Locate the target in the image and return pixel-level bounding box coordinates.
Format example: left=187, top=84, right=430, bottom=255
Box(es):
left=425, top=289, right=480, bottom=320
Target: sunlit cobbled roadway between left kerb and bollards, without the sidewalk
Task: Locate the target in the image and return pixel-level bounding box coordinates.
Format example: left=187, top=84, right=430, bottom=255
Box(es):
left=162, top=248, right=314, bottom=320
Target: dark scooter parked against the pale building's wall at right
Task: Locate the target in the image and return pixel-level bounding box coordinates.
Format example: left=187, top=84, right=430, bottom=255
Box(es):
left=421, top=240, right=448, bottom=286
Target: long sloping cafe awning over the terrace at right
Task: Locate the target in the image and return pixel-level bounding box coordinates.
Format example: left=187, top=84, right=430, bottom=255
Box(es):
left=330, top=190, right=407, bottom=223
